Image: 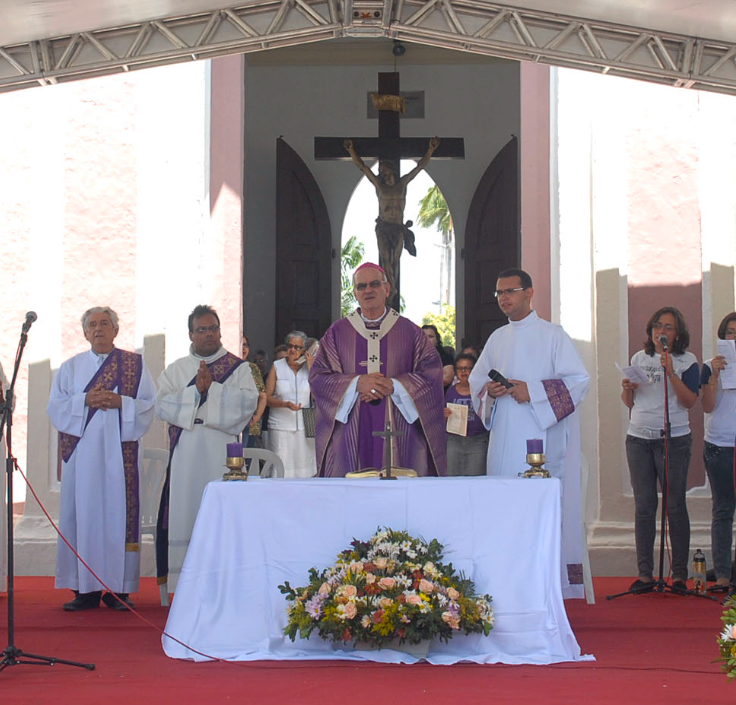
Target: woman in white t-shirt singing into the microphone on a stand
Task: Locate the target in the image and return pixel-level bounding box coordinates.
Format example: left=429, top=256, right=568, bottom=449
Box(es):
left=621, top=306, right=699, bottom=592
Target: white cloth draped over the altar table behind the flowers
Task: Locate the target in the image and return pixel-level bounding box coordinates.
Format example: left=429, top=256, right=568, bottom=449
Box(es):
left=163, top=477, right=591, bottom=664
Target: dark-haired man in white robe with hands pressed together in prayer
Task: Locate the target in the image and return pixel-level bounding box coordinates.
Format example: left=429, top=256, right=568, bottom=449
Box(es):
left=156, top=305, right=258, bottom=592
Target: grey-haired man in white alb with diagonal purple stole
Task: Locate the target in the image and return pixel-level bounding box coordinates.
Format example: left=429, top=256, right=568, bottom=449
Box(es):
left=47, top=306, right=156, bottom=612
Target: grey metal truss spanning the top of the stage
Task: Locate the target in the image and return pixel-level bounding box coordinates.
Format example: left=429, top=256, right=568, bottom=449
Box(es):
left=0, top=0, right=736, bottom=95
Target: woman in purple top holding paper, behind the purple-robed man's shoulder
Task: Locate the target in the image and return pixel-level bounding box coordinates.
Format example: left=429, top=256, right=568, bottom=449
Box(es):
left=445, top=353, right=488, bottom=476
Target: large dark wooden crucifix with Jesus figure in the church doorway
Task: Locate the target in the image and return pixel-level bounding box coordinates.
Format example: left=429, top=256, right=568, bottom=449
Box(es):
left=314, top=72, right=465, bottom=311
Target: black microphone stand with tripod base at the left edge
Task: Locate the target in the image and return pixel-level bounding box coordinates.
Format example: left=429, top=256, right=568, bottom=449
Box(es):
left=0, top=319, right=95, bottom=671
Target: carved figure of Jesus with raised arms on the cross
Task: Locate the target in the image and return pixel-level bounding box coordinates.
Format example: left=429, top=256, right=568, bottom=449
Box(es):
left=343, top=137, right=440, bottom=306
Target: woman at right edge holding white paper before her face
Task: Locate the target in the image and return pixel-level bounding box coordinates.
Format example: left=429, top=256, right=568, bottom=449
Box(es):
left=700, top=311, right=736, bottom=592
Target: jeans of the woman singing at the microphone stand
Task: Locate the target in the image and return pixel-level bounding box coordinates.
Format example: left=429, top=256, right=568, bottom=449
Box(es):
left=626, top=433, right=692, bottom=580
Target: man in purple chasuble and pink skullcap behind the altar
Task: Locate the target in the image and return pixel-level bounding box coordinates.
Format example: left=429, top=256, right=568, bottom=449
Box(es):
left=309, top=263, right=447, bottom=477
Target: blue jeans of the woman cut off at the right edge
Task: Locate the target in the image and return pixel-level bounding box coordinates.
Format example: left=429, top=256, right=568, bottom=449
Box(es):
left=703, top=441, right=736, bottom=578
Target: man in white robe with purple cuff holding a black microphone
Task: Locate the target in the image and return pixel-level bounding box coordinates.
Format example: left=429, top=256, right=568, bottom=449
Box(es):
left=470, top=269, right=590, bottom=597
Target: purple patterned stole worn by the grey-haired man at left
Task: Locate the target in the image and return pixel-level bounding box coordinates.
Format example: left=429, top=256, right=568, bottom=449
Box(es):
left=59, top=348, right=143, bottom=551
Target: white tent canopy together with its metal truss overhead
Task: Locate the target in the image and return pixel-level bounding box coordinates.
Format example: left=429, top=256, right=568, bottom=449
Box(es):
left=0, top=0, right=736, bottom=93
